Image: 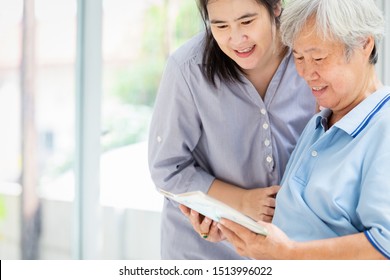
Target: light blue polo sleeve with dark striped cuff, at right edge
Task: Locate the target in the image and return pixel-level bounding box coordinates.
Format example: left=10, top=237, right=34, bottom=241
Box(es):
left=357, top=118, right=390, bottom=259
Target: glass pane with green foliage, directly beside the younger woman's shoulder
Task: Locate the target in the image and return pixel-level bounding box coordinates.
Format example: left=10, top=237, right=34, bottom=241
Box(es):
left=101, top=0, right=201, bottom=259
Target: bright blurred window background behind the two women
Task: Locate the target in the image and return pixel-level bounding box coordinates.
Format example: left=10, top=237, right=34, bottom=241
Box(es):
left=0, top=0, right=390, bottom=260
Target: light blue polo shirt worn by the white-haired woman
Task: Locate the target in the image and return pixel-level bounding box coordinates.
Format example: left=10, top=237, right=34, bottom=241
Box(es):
left=273, top=87, right=390, bottom=258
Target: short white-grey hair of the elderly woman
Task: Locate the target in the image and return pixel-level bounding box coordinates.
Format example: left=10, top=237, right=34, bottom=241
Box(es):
left=281, top=0, right=384, bottom=64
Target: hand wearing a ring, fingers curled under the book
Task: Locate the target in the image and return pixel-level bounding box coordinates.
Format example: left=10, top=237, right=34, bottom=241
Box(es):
left=179, top=205, right=225, bottom=242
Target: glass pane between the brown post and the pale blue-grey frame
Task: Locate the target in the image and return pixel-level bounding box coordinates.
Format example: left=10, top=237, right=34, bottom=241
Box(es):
left=35, top=0, right=77, bottom=259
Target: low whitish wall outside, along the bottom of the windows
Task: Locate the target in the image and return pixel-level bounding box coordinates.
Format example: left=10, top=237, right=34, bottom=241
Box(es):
left=0, top=191, right=160, bottom=260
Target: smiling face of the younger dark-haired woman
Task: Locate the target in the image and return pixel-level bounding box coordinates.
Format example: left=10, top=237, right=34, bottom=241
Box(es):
left=207, top=0, right=280, bottom=70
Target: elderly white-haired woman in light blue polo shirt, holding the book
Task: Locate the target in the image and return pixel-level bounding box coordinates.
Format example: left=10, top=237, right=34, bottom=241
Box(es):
left=203, top=0, right=390, bottom=259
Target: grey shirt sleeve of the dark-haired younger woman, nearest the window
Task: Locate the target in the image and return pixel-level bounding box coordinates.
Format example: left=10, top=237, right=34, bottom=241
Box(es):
left=148, top=57, right=214, bottom=196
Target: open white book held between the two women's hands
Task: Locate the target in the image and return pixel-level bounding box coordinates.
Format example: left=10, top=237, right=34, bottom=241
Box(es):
left=159, top=189, right=267, bottom=235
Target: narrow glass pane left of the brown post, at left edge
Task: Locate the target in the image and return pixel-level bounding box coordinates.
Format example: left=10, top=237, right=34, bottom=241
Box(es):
left=0, top=0, right=23, bottom=259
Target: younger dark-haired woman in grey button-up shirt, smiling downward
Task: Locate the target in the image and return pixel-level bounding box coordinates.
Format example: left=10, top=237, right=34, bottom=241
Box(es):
left=149, top=0, right=316, bottom=259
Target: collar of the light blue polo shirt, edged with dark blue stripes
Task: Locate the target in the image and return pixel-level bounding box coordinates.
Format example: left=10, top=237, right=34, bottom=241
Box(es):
left=316, top=87, right=390, bottom=137
